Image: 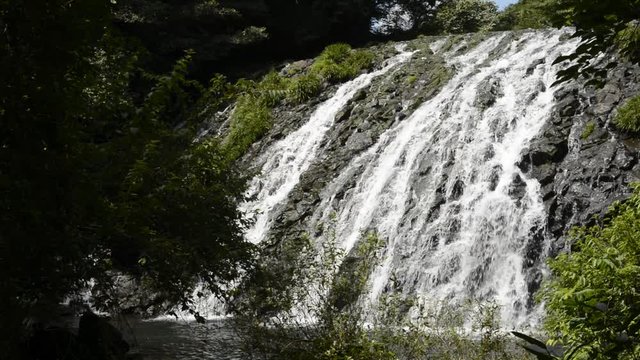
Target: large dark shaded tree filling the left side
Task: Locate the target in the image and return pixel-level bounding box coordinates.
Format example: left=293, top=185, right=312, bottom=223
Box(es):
left=0, top=0, right=252, bottom=356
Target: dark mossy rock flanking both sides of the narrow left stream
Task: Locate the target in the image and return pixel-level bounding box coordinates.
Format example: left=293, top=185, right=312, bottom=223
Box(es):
left=250, top=38, right=452, bottom=242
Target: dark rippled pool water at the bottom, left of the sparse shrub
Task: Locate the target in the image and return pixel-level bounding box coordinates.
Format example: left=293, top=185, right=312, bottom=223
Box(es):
left=127, top=320, right=242, bottom=360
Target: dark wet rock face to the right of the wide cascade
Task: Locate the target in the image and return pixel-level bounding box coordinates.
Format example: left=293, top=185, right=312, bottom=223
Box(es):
left=519, top=59, right=640, bottom=254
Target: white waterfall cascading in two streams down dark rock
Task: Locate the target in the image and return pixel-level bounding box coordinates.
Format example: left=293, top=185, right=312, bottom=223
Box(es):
left=244, top=30, right=576, bottom=327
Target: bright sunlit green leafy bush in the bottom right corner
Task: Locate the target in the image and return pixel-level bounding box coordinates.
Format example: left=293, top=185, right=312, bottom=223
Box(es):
left=540, top=184, right=640, bottom=359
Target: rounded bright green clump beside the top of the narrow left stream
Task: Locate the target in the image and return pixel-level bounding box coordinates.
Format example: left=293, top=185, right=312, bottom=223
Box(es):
left=310, top=44, right=374, bottom=83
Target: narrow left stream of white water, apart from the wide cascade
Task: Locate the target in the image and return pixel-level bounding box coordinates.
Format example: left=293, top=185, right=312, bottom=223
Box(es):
left=241, top=48, right=413, bottom=243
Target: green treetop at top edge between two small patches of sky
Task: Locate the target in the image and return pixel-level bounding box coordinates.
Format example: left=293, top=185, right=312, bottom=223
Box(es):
left=435, top=0, right=498, bottom=34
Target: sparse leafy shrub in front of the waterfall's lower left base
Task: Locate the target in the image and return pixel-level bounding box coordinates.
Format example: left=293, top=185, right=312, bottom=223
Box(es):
left=235, top=229, right=394, bottom=360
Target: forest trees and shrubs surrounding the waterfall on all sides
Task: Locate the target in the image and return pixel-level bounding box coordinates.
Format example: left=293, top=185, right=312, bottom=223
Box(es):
left=0, top=0, right=640, bottom=360
